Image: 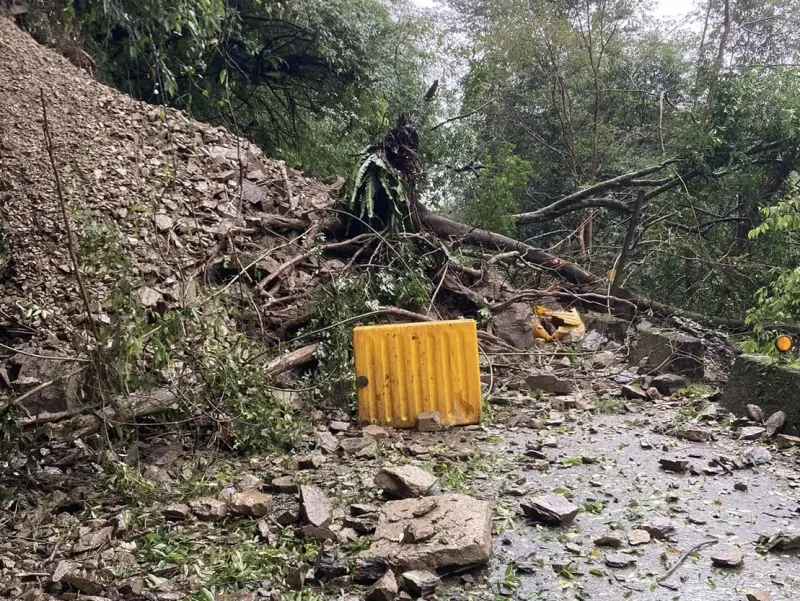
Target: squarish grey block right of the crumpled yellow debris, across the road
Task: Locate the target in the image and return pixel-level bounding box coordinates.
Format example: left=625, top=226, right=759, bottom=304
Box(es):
left=630, top=328, right=705, bottom=378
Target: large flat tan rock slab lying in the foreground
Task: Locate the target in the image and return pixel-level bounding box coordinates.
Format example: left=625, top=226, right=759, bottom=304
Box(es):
left=357, top=494, right=492, bottom=571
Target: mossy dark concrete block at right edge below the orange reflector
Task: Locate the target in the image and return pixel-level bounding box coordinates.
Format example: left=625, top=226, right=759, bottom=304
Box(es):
left=720, top=355, right=800, bottom=436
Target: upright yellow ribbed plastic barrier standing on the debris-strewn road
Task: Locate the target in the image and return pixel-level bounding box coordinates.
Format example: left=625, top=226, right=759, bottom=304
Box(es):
left=353, top=320, right=482, bottom=428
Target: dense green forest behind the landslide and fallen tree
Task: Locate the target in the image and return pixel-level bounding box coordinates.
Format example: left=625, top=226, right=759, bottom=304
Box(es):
left=18, top=0, right=800, bottom=332
